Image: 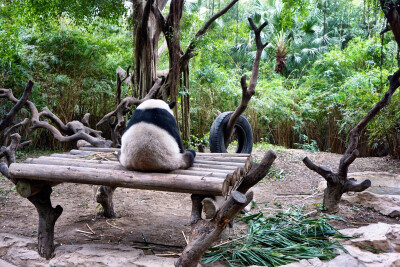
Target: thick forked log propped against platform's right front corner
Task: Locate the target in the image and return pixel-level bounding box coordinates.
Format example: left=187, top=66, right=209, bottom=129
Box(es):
left=175, top=150, right=276, bottom=267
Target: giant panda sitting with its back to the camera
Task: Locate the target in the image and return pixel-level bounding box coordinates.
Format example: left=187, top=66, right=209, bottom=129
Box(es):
left=119, top=99, right=196, bottom=172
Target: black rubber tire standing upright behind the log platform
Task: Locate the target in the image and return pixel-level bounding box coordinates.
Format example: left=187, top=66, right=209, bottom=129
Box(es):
left=210, top=111, right=253, bottom=154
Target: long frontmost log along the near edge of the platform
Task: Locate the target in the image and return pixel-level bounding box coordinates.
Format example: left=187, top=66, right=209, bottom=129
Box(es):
left=9, top=163, right=230, bottom=196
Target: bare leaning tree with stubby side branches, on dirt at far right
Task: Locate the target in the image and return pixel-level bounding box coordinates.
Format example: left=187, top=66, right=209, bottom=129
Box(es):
left=303, top=70, right=400, bottom=212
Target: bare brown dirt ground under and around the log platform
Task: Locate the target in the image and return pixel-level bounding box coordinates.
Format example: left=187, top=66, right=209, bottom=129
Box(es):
left=0, top=149, right=400, bottom=260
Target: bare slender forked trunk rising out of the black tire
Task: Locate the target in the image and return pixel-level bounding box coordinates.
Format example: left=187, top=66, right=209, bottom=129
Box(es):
left=224, top=18, right=268, bottom=145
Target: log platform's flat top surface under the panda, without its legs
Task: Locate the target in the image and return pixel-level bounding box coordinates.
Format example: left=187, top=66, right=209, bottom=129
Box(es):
left=9, top=147, right=251, bottom=196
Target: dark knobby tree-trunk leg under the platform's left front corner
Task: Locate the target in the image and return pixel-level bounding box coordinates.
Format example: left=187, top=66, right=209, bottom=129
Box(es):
left=28, top=186, right=63, bottom=259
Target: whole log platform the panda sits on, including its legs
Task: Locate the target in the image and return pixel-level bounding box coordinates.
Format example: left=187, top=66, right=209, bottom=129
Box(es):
left=8, top=150, right=252, bottom=258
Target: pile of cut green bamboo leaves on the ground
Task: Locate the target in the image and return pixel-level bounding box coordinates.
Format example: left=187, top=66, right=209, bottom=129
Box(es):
left=202, top=208, right=348, bottom=266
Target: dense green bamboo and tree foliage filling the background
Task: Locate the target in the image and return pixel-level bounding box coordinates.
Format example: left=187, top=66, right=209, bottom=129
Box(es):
left=0, top=0, right=400, bottom=155
